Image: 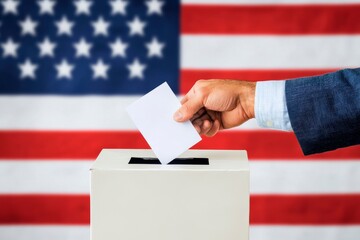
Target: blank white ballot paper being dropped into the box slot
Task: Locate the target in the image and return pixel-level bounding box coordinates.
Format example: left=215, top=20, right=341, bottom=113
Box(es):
left=127, top=82, right=201, bottom=164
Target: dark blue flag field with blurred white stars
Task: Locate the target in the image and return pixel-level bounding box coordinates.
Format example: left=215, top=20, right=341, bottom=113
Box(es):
left=0, top=0, right=179, bottom=95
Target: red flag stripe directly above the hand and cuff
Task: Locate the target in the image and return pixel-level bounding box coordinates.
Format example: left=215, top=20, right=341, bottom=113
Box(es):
left=180, top=69, right=336, bottom=94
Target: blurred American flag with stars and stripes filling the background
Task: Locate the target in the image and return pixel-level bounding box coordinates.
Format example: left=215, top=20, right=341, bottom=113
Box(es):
left=0, top=0, right=360, bottom=240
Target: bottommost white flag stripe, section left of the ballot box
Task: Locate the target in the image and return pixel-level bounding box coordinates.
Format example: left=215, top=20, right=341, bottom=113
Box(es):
left=0, top=225, right=90, bottom=240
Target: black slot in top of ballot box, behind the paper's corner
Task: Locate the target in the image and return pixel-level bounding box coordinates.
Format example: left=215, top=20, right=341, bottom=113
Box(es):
left=129, top=157, right=209, bottom=165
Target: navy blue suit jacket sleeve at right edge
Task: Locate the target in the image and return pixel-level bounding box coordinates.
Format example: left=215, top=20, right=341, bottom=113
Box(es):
left=285, top=68, right=360, bottom=155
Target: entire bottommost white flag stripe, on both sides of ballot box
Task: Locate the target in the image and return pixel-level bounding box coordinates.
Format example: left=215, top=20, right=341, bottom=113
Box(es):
left=0, top=225, right=360, bottom=240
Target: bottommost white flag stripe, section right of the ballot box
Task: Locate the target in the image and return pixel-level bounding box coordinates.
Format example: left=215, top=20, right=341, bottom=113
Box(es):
left=250, top=225, right=360, bottom=240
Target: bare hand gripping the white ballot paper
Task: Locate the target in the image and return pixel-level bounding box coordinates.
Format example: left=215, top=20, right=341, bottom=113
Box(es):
left=174, top=79, right=256, bottom=136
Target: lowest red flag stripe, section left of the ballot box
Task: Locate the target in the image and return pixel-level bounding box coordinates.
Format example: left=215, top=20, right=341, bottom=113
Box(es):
left=0, top=194, right=90, bottom=224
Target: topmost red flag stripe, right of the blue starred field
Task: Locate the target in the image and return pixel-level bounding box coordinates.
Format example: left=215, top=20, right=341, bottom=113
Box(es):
left=181, top=4, right=360, bottom=34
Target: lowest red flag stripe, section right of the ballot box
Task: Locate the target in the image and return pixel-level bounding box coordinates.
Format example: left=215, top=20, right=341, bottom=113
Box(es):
left=250, top=194, right=360, bottom=225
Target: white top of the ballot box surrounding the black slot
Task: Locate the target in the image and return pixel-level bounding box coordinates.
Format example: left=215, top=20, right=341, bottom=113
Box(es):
left=91, top=149, right=249, bottom=171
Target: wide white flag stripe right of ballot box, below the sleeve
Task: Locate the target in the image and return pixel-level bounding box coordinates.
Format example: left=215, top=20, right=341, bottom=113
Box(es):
left=250, top=160, right=360, bottom=194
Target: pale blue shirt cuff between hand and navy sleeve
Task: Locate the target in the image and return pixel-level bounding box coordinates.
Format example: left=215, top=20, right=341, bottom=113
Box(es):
left=255, top=81, right=292, bottom=131
